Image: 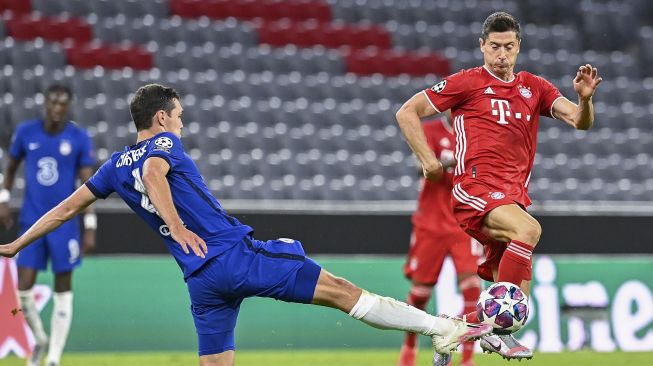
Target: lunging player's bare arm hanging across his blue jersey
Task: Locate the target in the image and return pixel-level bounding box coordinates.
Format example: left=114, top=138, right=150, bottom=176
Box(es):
left=142, top=156, right=208, bottom=258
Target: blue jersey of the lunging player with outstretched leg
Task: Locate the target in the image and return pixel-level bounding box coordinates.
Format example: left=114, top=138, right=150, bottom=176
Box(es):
left=86, top=132, right=253, bottom=278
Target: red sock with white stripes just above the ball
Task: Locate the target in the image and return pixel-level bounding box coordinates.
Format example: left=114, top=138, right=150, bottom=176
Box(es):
left=497, top=240, right=533, bottom=287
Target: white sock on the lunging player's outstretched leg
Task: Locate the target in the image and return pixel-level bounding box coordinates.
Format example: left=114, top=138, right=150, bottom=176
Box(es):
left=349, top=290, right=454, bottom=336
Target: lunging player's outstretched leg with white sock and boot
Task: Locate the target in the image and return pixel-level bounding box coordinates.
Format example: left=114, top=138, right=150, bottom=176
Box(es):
left=313, top=270, right=492, bottom=354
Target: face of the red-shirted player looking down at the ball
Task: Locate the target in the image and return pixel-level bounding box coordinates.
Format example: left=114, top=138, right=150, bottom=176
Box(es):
left=479, top=31, right=520, bottom=75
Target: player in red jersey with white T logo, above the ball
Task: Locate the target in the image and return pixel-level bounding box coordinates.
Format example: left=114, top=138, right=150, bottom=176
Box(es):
left=397, top=12, right=601, bottom=359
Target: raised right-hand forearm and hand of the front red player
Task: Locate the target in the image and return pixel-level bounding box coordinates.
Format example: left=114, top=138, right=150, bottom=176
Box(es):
left=551, top=64, right=603, bottom=130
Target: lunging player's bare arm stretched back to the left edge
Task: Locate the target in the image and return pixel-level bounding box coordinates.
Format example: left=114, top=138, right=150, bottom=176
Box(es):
left=0, top=185, right=97, bottom=258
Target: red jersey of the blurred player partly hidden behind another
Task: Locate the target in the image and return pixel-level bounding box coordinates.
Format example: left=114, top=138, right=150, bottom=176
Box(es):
left=413, top=119, right=462, bottom=235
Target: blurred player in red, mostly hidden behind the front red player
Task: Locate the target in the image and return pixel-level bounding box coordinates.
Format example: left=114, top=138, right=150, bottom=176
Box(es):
left=398, top=113, right=483, bottom=366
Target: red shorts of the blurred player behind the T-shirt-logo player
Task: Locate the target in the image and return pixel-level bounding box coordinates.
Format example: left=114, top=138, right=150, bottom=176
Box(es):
left=404, top=227, right=483, bottom=285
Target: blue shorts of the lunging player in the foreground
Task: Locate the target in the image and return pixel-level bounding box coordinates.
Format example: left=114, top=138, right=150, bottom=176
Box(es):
left=186, top=237, right=321, bottom=356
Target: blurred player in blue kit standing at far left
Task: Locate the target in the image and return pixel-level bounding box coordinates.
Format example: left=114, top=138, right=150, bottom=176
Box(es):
left=0, top=85, right=97, bottom=366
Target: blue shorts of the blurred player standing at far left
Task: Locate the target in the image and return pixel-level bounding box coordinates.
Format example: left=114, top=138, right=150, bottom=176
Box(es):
left=16, top=221, right=81, bottom=273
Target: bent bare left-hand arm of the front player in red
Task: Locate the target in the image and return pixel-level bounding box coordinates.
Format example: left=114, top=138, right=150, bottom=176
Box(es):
left=396, top=92, right=443, bottom=180
